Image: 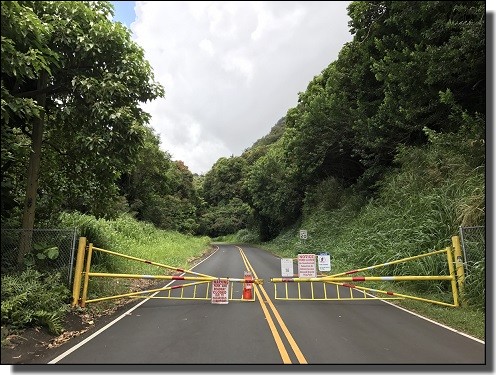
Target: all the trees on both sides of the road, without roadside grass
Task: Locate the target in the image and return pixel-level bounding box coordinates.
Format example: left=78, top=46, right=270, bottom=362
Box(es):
left=1, top=1, right=486, bottom=260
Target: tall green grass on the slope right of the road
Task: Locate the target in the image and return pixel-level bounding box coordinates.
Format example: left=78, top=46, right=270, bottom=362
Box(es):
left=261, top=145, right=485, bottom=339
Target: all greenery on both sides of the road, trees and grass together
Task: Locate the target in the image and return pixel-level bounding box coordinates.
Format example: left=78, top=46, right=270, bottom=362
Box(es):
left=1, top=1, right=487, bottom=348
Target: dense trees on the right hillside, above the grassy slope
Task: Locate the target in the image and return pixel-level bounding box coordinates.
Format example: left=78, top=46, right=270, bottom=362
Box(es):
left=204, top=1, right=486, bottom=240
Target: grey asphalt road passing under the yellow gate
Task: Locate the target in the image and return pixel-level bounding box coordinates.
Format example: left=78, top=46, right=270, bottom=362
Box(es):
left=49, top=245, right=486, bottom=369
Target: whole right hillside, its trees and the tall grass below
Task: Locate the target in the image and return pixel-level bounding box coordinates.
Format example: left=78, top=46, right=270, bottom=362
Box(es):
left=198, top=1, right=486, bottom=308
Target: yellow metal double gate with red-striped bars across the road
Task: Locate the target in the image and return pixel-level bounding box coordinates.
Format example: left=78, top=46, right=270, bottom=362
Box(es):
left=72, top=236, right=464, bottom=307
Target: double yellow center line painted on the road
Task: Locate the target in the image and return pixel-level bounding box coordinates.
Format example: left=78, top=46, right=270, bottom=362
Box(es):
left=236, top=246, right=307, bottom=364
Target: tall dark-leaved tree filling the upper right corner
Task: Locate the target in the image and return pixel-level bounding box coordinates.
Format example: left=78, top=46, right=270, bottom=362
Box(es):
left=344, top=1, right=485, bottom=165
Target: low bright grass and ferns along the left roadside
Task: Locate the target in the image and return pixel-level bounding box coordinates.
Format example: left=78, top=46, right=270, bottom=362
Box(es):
left=1, top=213, right=210, bottom=341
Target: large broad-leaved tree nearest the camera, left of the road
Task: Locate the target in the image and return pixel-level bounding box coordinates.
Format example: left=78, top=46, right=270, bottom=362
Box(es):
left=2, top=1, right=163, bottom=260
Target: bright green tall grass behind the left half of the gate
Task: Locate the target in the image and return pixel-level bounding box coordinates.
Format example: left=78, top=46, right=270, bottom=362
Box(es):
left=60, top=213, right=210, bottom=310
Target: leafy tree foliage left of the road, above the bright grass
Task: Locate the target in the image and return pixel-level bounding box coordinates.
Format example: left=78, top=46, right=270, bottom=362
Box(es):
left=1, top=1, right=196, bottom=231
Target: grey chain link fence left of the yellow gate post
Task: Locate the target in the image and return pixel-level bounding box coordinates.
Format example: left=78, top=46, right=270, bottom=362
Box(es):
left=0, top=228, right=78, bottom=286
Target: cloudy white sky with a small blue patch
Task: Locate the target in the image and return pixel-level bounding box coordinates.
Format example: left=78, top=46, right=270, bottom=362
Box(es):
left=112, top=1, right=352, bottom=174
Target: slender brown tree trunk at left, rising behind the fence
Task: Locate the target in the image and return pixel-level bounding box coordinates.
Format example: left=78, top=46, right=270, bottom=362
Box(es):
left=17, top=71, right=48, bottom=265
